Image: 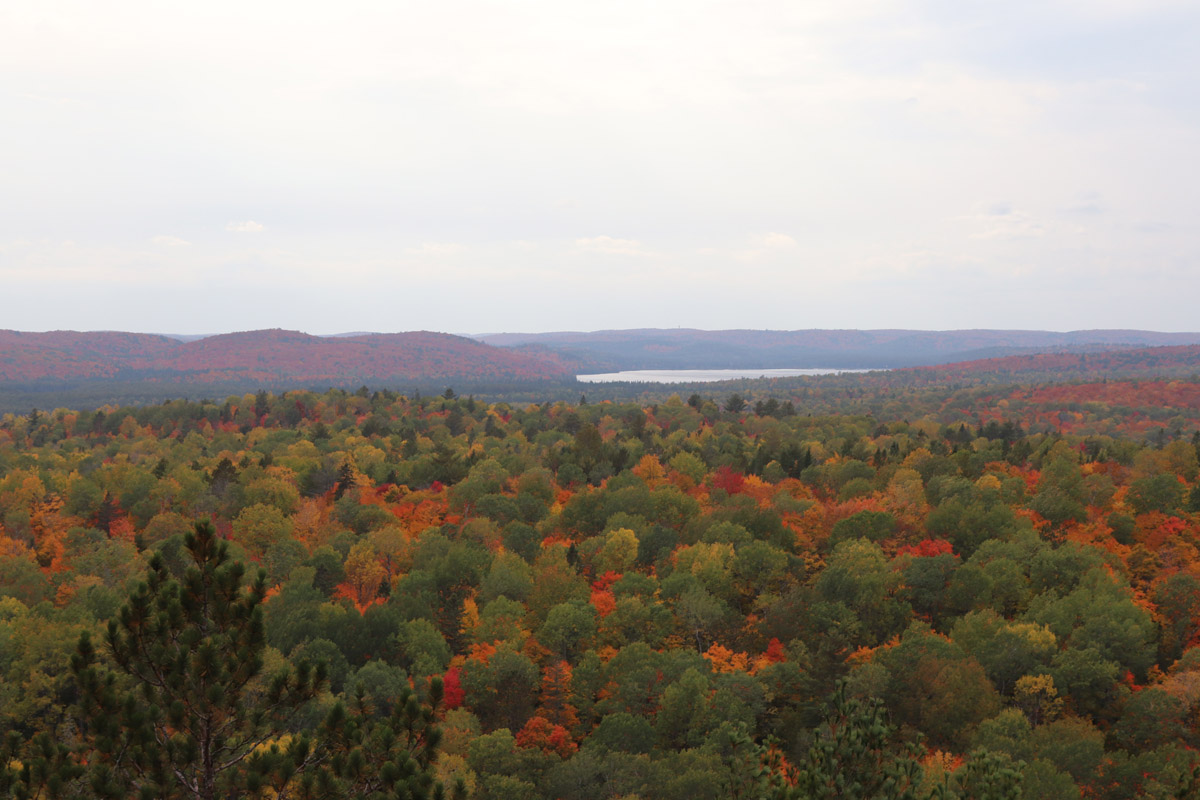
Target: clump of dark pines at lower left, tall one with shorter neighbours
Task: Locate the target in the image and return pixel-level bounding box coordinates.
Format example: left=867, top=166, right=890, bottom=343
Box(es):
left=0, top=522, right=453, bottom=800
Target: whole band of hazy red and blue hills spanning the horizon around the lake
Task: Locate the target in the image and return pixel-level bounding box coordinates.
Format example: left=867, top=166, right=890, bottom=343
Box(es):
left=0, top=329, right=1200, bottom=410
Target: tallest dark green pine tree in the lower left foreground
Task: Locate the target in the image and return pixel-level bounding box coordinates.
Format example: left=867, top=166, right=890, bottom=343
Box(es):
left=71, top=522, right=325, bottom=800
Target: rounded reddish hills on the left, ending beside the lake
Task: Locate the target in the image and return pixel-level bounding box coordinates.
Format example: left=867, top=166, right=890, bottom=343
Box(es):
left=0, top=330, right=576, bottom=385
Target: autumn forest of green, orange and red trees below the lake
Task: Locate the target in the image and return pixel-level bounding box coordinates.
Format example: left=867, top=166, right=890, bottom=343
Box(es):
left=0, top=383, right=1200, bottom=800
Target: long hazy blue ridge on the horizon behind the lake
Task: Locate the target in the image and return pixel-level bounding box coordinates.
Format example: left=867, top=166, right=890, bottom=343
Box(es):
left=476, top=329, right=1200, bottom=371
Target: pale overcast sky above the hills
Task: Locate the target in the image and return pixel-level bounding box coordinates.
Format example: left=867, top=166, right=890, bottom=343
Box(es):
left=0, top=0, right=1200, bottom=333
